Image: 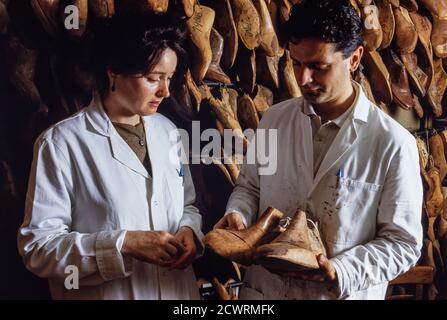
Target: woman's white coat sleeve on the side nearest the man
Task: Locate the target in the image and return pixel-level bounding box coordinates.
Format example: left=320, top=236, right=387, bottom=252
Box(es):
left=179, top=164, right=205, bottom=256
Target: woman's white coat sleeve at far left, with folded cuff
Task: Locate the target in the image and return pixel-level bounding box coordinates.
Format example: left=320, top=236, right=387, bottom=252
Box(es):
left=18, top=139, right=131, bottom=285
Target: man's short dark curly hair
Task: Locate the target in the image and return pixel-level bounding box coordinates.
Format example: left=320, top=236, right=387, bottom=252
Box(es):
left=281, top=0, right=363, bottom=59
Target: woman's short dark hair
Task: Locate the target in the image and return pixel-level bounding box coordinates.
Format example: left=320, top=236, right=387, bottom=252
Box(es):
left=92, top=14, right=188, bottom=92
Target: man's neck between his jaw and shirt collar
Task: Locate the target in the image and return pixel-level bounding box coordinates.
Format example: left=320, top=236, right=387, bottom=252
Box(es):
left=312, top=85, right=356, bottom=123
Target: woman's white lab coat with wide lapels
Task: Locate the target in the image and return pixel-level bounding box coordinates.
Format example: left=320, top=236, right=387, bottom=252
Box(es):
left=18, top=97, right=202, bottom=299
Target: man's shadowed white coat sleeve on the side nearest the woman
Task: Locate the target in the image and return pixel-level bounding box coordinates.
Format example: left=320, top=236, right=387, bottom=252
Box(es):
left=225, top=132, right=260, bottom=227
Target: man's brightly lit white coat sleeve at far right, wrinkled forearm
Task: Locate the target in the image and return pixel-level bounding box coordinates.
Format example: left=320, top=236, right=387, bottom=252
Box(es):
left=331, top=139, right=423, bottom=298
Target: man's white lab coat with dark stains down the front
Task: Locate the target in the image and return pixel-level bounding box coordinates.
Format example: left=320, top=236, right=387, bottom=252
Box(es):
left=227, top=84, right=422, bottom=299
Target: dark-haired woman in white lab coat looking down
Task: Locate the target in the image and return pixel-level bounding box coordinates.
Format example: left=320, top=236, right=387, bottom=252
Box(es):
left=18, top=16, right=203, bottom=299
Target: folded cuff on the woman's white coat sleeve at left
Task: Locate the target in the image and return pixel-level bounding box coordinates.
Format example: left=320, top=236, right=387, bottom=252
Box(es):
left=96, top=230, right=132, bottom=280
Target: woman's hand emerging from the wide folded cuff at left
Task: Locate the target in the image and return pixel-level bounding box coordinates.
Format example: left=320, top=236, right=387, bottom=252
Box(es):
left=121, top=231, right=186, bottom=267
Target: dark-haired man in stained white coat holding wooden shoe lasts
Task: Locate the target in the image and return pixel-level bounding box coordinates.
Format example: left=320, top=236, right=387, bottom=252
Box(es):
left=216, top=0, right=422, bottom=299
